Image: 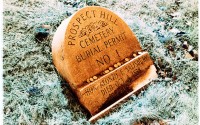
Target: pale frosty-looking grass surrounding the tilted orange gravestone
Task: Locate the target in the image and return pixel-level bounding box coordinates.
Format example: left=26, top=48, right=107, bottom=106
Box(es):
left=3, top=0, right=198, bottom=125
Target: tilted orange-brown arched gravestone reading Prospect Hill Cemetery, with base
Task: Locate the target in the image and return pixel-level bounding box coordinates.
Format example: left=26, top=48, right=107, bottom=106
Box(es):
left=52, top=7, right=157, bottom=121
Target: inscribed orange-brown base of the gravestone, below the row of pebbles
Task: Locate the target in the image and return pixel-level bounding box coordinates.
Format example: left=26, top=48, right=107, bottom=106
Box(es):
left=76, top=52, right=153, bottom=115
